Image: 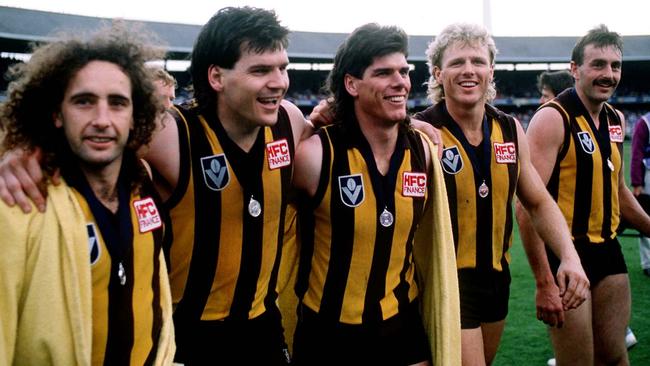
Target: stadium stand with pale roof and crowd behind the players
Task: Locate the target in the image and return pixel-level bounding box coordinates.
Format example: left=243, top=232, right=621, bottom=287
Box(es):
left=0, top=6, right=650, bottom=136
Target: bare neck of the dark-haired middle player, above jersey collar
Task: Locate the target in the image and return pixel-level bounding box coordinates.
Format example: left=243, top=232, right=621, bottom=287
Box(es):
left=357, top=114, right=399, bottom=175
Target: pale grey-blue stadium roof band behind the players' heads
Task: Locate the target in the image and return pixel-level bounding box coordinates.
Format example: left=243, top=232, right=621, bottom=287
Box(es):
left=0, top=6, right=650, bottom=63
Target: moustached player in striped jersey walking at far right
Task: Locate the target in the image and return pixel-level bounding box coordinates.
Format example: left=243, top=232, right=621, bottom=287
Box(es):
left=519, top=25, right=650, bottom=365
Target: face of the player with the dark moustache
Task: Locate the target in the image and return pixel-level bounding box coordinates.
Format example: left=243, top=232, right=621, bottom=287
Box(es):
left=571, top=44, right=622, bottom=104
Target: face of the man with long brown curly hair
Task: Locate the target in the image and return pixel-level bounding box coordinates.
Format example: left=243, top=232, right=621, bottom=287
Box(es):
left=54, top=61, right=133, bottom=171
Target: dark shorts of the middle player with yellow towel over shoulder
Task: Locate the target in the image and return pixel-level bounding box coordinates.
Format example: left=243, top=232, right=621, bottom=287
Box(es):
left=293, top=301, right=431, bottom=365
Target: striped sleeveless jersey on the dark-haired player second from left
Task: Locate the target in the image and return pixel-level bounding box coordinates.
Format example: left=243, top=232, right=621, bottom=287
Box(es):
left=168, top=104, right=294, bottom=322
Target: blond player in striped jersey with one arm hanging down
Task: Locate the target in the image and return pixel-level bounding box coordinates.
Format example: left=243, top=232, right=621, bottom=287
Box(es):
left=415, top=24, right=589, bottom=365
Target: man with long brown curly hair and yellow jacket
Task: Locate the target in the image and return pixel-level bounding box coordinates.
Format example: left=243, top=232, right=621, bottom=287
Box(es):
left=0, top=26, right=174, bottom=365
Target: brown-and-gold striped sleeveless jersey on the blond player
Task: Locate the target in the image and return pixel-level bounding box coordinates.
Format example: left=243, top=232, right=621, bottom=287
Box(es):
left=415, top=103, right=519, bottom=271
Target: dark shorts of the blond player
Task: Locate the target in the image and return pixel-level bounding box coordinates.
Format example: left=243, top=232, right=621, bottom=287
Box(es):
left=458, top=269, right=510, bottom=329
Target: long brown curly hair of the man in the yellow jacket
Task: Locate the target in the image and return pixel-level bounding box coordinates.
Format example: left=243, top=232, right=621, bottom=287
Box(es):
left=0, top=21, right=164, bottom=176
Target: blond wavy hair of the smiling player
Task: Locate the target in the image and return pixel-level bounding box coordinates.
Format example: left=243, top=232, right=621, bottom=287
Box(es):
left=426, top=23, right=498, bottom=104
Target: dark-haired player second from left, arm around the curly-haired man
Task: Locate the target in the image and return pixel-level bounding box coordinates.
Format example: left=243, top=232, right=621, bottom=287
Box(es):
left=0, top=7, right=312, bottom=365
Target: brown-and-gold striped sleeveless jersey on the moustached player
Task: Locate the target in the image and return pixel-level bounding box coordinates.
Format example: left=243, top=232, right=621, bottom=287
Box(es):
left=541, top=88, right=625, bottom=243
